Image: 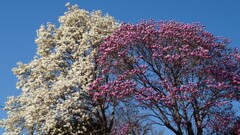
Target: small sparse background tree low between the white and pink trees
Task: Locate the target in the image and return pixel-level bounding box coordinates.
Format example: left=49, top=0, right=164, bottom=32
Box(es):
left=112, top=99, right=163, bottom=135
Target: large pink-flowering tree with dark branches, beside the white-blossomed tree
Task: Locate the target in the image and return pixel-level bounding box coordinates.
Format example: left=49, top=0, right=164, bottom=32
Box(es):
left=89, top=20, right=240, bottom=135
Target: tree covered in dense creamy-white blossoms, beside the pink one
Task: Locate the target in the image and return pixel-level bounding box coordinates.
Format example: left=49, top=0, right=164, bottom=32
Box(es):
left=0, top=4, right=118, bottom=135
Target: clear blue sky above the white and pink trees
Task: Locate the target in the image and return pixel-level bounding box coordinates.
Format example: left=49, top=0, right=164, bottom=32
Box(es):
left=0, top=0, right=240, bottom=134
